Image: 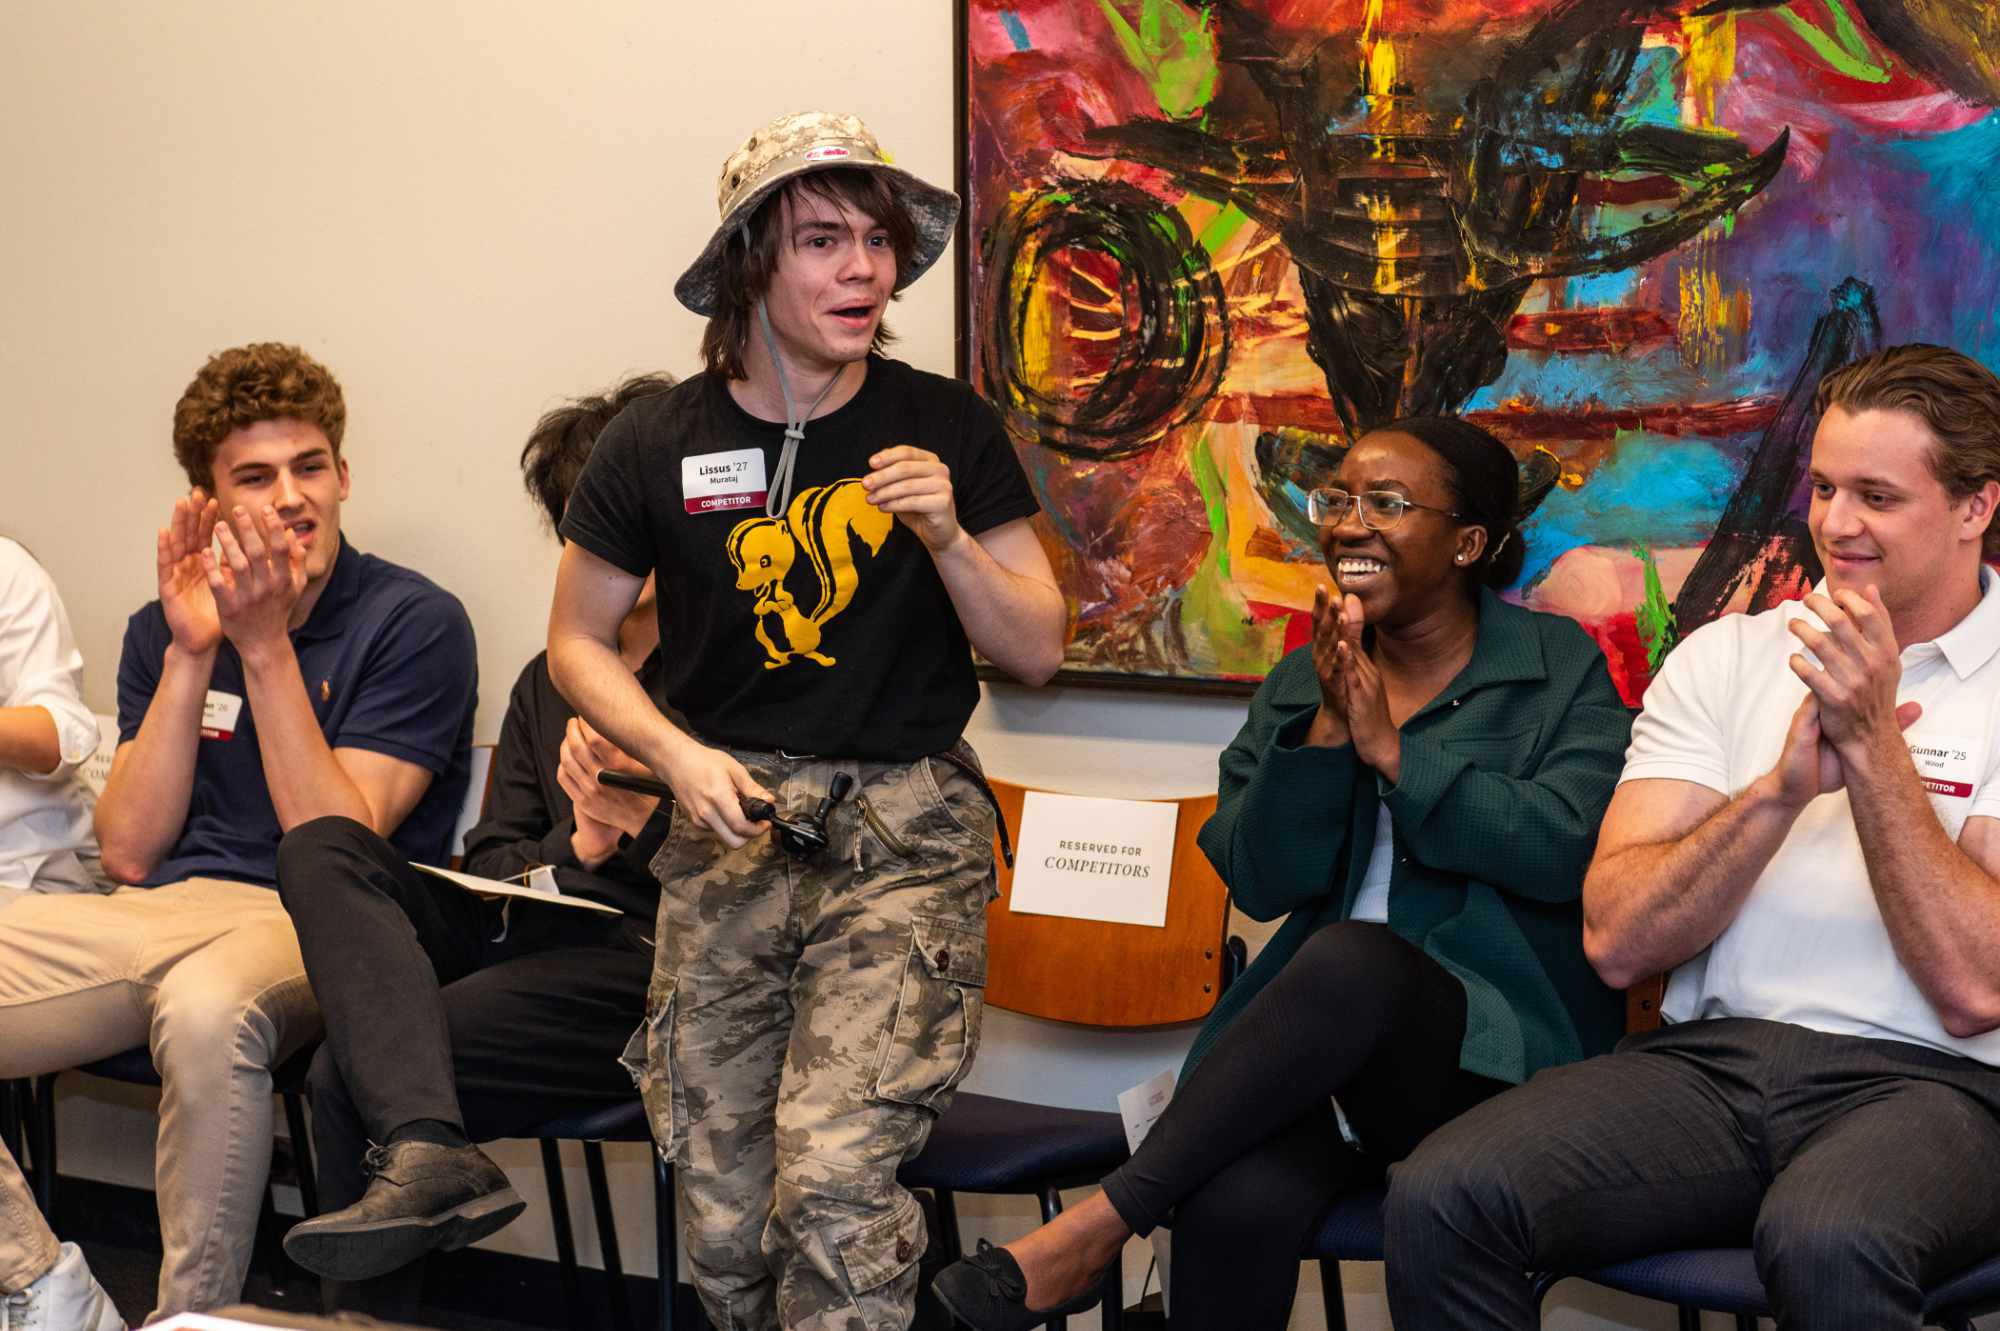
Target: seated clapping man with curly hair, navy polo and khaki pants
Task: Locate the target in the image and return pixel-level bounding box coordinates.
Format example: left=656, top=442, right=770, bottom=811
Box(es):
left=0, top=342, right=476, bottom=1321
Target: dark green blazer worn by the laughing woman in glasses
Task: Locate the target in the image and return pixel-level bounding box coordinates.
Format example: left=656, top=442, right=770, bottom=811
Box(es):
left=1182, top=590, right=1632, bottom=1081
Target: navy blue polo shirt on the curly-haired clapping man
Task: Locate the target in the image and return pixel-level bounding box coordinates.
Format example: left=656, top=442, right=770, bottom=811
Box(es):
left=118, top=538, right=478, bottom=887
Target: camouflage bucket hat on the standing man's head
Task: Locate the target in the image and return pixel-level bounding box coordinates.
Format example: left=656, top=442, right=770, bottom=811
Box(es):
left=674, top=112, right=958, bottom=314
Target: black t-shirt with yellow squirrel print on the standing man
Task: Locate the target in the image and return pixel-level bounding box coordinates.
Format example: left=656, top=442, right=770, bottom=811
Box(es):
left=562, top=356, right=1038, bottom=761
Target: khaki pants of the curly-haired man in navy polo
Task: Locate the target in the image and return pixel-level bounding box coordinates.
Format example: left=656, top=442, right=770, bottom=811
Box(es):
left=0, top=877, right=320, bottom=1321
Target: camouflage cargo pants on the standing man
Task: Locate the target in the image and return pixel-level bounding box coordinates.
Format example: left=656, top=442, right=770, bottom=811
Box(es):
left=628, top=749, right=994, bottom=1331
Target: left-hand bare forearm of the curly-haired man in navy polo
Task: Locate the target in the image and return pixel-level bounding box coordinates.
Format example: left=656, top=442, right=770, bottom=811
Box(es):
left=96, top=646, right=216, bottom=883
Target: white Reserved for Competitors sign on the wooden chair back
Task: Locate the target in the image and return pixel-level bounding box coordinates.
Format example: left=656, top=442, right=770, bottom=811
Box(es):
left=1008, top=789, right=1180, bottom=929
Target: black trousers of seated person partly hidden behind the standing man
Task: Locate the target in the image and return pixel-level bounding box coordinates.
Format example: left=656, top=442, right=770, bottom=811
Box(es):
left=278, top=817, right=652, bottom=1313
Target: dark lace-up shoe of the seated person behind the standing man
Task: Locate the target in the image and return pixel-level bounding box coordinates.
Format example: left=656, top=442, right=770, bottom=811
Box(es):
left=284, top=1141, right=528, bottom=1281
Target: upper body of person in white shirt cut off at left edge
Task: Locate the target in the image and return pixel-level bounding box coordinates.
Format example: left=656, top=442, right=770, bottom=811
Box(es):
left=0, top=536, right=98, bottom=907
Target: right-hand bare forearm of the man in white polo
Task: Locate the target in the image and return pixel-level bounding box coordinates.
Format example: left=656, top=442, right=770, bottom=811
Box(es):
left=1842, top=739, right=2000, bottom=1037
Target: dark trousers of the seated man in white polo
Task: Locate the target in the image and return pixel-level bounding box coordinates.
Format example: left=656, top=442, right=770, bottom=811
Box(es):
left=1386, top=1019, right=2000, bottom=1331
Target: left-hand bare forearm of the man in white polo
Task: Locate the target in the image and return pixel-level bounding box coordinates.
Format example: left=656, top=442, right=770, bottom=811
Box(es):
left=1584, top=779, right=1798, bottom=989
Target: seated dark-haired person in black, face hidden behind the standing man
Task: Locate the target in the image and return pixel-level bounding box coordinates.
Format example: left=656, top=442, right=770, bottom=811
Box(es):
left=278, top=376, right=674, bottom=1315
